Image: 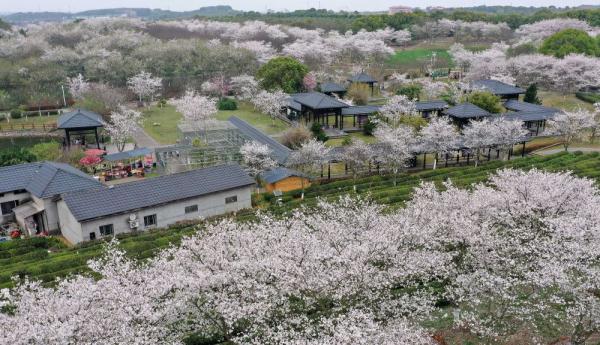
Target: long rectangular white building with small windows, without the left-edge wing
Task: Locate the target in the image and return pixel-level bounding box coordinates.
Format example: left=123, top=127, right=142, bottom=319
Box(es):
left=58, top=165, right=254, bottom=243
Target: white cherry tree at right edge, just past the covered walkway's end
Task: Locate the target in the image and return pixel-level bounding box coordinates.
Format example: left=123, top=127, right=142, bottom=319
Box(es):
left=548, top=108, right=596, bottom=151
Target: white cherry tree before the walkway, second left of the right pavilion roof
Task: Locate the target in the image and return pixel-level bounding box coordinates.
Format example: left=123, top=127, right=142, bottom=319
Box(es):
left=375, top=124, right=416, bottom=186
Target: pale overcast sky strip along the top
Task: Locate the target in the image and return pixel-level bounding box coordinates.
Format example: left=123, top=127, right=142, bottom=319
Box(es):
left=0, top=0, right=600, bottom=12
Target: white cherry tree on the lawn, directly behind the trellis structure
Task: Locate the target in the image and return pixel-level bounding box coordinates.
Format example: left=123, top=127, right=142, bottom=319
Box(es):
left=173, top=90, right=217, bottom=137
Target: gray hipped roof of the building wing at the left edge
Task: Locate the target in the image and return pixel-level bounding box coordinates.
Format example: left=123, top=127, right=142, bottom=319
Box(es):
left=0, top=162, right=101, bottom=198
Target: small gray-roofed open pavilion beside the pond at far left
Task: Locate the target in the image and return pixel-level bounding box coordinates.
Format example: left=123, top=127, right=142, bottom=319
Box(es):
left=57, top=109, right=105, bottom=148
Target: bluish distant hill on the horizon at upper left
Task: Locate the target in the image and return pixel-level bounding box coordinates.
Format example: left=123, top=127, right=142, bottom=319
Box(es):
left=0, top=6, right=240, bottom=24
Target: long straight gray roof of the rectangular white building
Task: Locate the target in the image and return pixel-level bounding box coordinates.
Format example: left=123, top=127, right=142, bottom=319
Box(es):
left=63, top=165, right=254, bottom=222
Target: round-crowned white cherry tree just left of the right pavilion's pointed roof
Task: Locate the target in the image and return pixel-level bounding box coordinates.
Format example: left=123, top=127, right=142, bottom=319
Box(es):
left=419, top=117, right=458, bottom=170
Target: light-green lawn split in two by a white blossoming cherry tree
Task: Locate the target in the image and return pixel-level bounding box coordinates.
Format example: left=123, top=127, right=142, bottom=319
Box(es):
left=143, top=102, right=288, bottom=144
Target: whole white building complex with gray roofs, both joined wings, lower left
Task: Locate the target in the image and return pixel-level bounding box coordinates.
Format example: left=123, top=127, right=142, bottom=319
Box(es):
left=0, top=162, right=254, bottom=244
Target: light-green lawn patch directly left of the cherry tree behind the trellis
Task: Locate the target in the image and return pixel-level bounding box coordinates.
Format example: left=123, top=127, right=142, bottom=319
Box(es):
left=143, top=105, right=181, bottom=144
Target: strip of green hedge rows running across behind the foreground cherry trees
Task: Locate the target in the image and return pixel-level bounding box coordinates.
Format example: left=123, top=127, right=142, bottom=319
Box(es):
left=0, top=153, right=600, bottom=288
